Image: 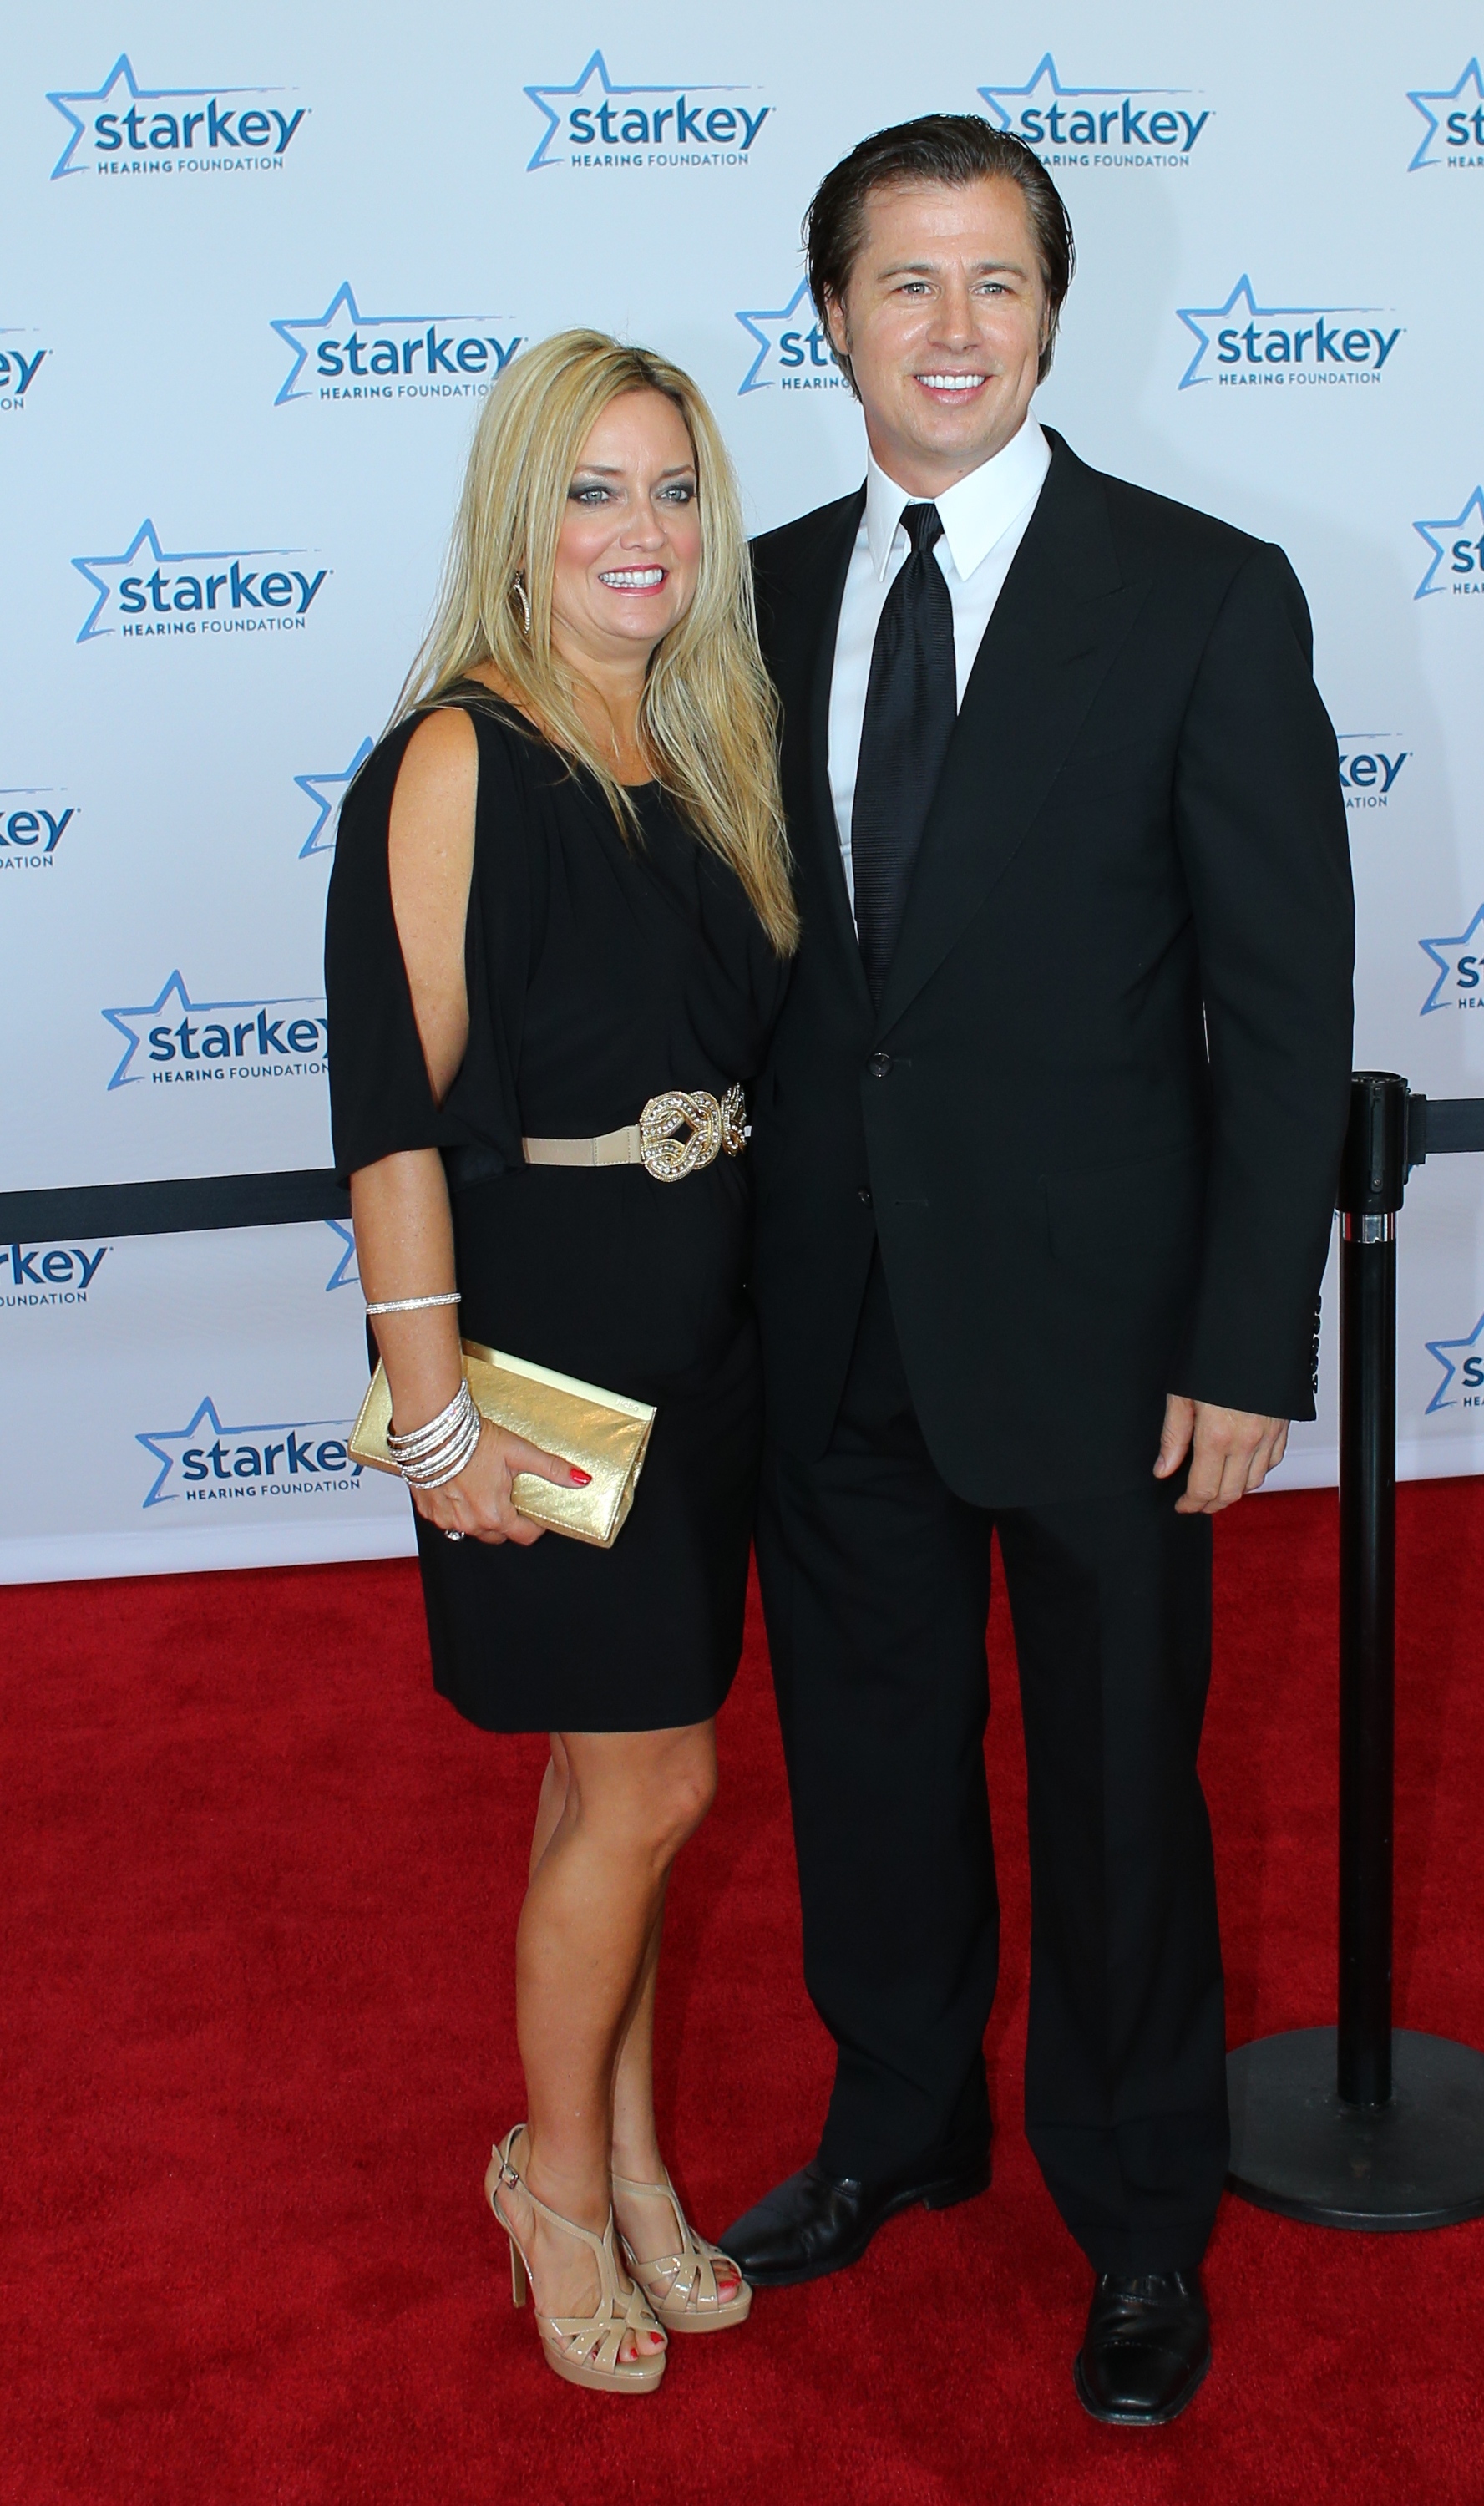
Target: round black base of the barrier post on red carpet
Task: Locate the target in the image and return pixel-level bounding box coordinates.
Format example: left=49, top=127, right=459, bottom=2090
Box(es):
left=1226, top=2027, right=1484, bottom=2230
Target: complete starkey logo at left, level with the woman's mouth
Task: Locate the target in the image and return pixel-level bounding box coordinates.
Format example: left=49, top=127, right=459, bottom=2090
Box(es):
left=73, top=519, right=331, bottom=644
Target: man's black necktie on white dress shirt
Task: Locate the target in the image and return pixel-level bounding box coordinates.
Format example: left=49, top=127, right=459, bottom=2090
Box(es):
left=850, top=504, right=958, bottom=1002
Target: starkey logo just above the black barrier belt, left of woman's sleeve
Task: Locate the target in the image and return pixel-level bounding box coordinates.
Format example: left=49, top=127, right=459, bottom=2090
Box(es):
left=100, top=967, right=328, bottom=1095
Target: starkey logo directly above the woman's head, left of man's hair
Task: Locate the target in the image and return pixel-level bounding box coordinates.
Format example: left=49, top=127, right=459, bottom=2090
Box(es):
left=526, top=53, right=775, bottom=173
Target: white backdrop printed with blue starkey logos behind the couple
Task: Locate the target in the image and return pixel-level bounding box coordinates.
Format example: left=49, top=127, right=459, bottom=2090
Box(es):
left=0, top=0, right=1484, bottom=1579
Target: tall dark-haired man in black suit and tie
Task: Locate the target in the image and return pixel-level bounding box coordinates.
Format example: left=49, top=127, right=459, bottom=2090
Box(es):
left=724, top=115, right=1351, bottom=2423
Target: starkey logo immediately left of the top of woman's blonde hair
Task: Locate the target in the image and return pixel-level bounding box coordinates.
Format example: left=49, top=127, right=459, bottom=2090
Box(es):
left=271, top=278, right=521, bottom=408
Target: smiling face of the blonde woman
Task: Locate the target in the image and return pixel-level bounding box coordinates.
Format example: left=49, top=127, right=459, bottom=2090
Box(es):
left=551, top=391, right=701, bottom=662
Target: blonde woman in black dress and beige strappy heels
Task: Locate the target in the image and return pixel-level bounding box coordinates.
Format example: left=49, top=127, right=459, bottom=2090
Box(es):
left=326, top=331, right=795, bottom=2391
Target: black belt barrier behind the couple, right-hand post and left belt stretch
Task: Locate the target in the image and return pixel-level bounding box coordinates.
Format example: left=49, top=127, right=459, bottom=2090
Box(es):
left=0, top=1070, right=1484, bottom=2228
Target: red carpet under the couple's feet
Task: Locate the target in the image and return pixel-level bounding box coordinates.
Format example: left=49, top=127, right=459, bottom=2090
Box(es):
left=0, top=1481, right=1484, bottom=2506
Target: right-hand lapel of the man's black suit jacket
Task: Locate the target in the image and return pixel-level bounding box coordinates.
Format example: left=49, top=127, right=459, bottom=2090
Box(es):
left=882, top=429, right=1146, bottom=1032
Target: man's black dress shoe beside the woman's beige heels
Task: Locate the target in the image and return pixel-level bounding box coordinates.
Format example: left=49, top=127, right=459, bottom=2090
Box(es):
left=722, top=2138, right=990, bottom=2288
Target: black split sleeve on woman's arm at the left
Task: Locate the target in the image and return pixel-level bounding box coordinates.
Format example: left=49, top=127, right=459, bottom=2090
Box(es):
left=326, top=707, right=529, bottom=1178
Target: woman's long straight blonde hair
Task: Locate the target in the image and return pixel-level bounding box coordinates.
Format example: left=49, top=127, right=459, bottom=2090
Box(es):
left=393, top=331, right=800, bottom=957
